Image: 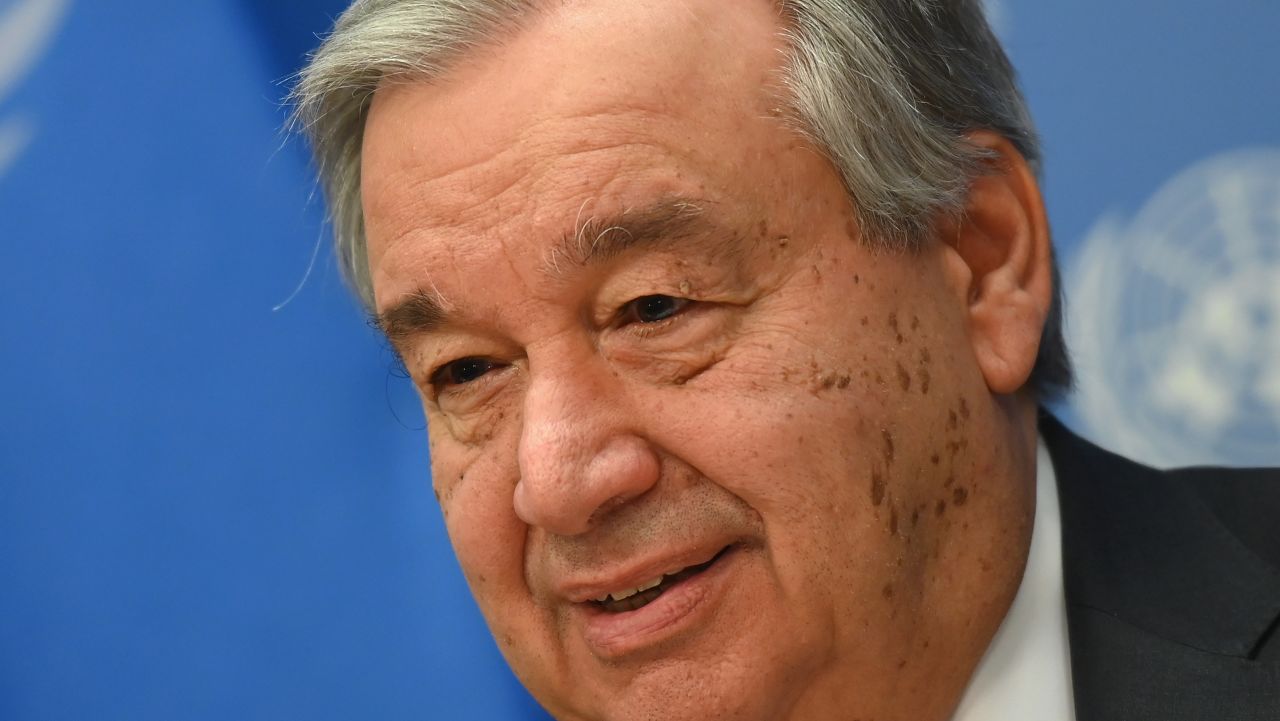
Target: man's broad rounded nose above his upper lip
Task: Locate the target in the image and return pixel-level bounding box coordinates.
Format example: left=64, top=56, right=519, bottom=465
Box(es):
left=513, top=356, right=660, bottom=535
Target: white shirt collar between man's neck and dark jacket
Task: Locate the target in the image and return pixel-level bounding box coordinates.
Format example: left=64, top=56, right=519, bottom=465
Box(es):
left=951, top=439, right=1075, bottom=721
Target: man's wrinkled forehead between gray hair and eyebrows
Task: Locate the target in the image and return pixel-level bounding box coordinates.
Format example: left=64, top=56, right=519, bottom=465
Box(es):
left=362, top=0, right=794, bottom=306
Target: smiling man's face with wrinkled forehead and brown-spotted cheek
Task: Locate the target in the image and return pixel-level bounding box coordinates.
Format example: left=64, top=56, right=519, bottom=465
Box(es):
left=362, top=1, right=1029, bottom=720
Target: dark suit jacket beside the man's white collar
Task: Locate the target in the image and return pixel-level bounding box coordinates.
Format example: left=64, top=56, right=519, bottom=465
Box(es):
left=1027, top=415, right=1280, bottom=721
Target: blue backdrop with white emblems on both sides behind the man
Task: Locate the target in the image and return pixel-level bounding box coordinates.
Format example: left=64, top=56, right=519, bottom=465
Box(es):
left=0, top=0, right=1280, bottom=721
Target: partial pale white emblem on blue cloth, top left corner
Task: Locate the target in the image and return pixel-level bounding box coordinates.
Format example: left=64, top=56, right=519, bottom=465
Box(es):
left=0, top=0, right=70, bottom=175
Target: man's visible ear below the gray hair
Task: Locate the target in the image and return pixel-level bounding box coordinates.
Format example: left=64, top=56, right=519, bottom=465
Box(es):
left=938, top=131, right=1053, bottom=394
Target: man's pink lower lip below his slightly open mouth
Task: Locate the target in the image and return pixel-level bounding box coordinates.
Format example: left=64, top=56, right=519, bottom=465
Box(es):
left=580, top=548, right=739, bottom=661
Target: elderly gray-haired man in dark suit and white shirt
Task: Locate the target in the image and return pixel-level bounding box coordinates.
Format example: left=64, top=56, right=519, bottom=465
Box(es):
left=294, top=0, right=1280, bottom=721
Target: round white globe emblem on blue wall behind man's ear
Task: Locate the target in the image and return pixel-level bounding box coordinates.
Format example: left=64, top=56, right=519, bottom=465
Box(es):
left=1066, top=149, right=1280, bottom=466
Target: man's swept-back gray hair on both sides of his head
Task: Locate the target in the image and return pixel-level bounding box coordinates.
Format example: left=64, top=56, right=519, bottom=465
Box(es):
left=289, top=0, right=1071, bottom=400
